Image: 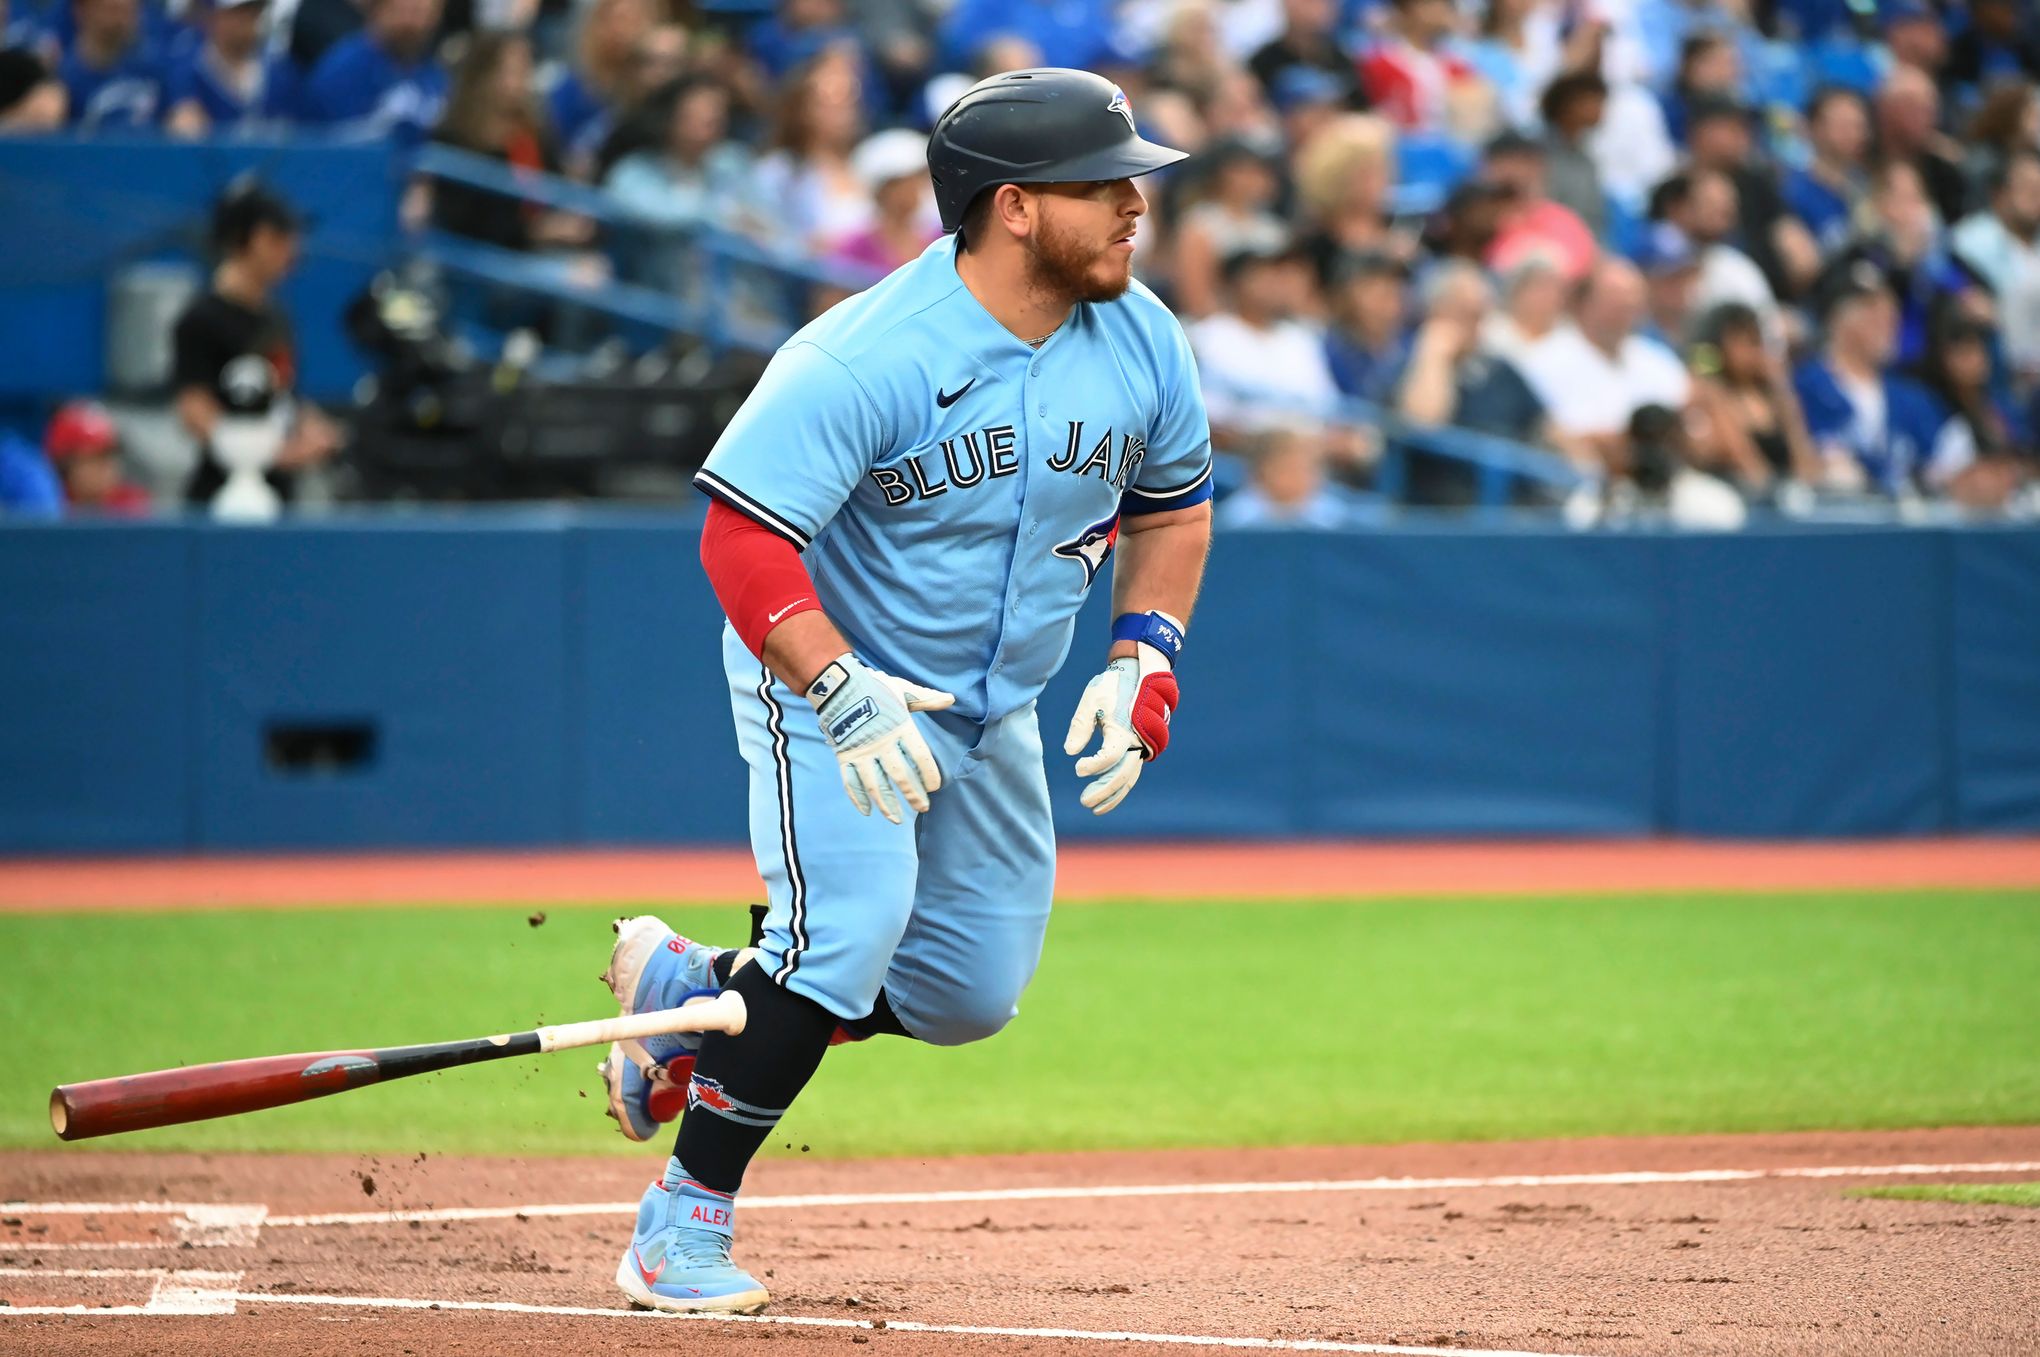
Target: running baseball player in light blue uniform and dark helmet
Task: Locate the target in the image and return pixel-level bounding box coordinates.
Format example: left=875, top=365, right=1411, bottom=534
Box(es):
left=602, top=69, right=1212, bottom=1314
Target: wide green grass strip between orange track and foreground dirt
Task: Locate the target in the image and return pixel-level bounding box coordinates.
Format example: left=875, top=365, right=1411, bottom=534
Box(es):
left=0, top=892, right=2040, bottom=1155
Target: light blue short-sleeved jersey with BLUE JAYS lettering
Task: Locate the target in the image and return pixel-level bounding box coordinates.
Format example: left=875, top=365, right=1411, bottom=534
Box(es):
left=696, top=235, right=1212, bottom=722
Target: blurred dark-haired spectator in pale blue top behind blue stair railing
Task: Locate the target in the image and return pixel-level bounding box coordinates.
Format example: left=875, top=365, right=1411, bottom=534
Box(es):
left=604, top=76, right=751, bottom=239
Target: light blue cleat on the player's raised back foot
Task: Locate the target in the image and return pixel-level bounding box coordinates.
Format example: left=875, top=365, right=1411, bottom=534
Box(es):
left=596, top=914, right=758, bottom=1141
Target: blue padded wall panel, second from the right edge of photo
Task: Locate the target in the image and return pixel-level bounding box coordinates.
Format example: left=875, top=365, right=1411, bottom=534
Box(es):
left=1667, top=531, right=1950, bottom=837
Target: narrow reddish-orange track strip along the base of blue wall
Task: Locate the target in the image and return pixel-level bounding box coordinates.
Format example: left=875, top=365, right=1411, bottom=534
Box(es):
left=0, top=839, right=2040, bottom=910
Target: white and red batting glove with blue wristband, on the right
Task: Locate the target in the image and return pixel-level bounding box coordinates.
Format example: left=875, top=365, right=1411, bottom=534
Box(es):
left=1063, top=612, right=1183, bottom=814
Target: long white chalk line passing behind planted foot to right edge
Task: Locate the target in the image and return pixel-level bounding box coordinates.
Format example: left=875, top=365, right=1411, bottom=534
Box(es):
left=263, top=1159, right=2040, bottom=1228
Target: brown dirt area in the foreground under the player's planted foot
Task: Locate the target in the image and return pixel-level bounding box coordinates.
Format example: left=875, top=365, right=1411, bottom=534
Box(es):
left=0, top=1128, right=2040, bottom=1357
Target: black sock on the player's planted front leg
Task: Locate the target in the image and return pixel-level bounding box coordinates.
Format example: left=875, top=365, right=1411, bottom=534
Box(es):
left=673, top=965, right=836, bottom=1192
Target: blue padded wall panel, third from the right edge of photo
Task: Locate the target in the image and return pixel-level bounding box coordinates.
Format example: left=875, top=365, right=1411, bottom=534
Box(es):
left=1297, top=533, right=1663, bottom=835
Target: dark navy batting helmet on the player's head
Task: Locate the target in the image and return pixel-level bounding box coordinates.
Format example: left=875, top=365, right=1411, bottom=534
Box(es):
left=928, top=65, right=1189, bottom=231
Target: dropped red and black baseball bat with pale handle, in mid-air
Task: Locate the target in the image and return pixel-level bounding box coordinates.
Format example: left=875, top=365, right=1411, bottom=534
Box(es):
left=49, top=992, right=745, bottom=1141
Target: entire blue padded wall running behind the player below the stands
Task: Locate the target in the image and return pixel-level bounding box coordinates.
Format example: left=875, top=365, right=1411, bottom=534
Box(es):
left=0, top=510, right=2040, bottom=853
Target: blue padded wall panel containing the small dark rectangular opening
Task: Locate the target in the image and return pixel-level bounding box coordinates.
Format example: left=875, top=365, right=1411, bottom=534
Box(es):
left=196, top=516, right=573, bottom=849
